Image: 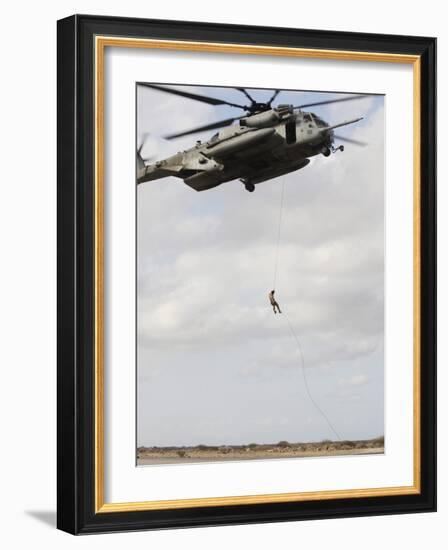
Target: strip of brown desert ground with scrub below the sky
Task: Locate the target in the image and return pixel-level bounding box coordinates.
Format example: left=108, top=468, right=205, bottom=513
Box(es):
left=137, top=437, right=384, bottom=466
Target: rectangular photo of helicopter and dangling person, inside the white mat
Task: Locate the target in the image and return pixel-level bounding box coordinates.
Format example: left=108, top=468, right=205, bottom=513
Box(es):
left=136, top=82, right=384, bottom=467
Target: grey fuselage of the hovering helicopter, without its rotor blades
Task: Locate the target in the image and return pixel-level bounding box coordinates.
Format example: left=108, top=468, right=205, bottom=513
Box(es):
left=137, top=105, right=360, bottom=191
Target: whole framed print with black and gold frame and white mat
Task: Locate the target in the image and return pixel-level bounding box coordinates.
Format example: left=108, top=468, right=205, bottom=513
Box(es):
left=58, top=15, right=436, bottom=534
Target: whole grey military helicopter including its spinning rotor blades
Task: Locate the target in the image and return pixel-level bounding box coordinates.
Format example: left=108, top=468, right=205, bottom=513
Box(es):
left=137, top=82, right=367, bottom=192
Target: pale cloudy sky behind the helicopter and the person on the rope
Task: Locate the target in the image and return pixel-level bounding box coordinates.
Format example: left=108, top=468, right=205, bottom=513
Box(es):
left=137, top=86, right=384, bottom=446
